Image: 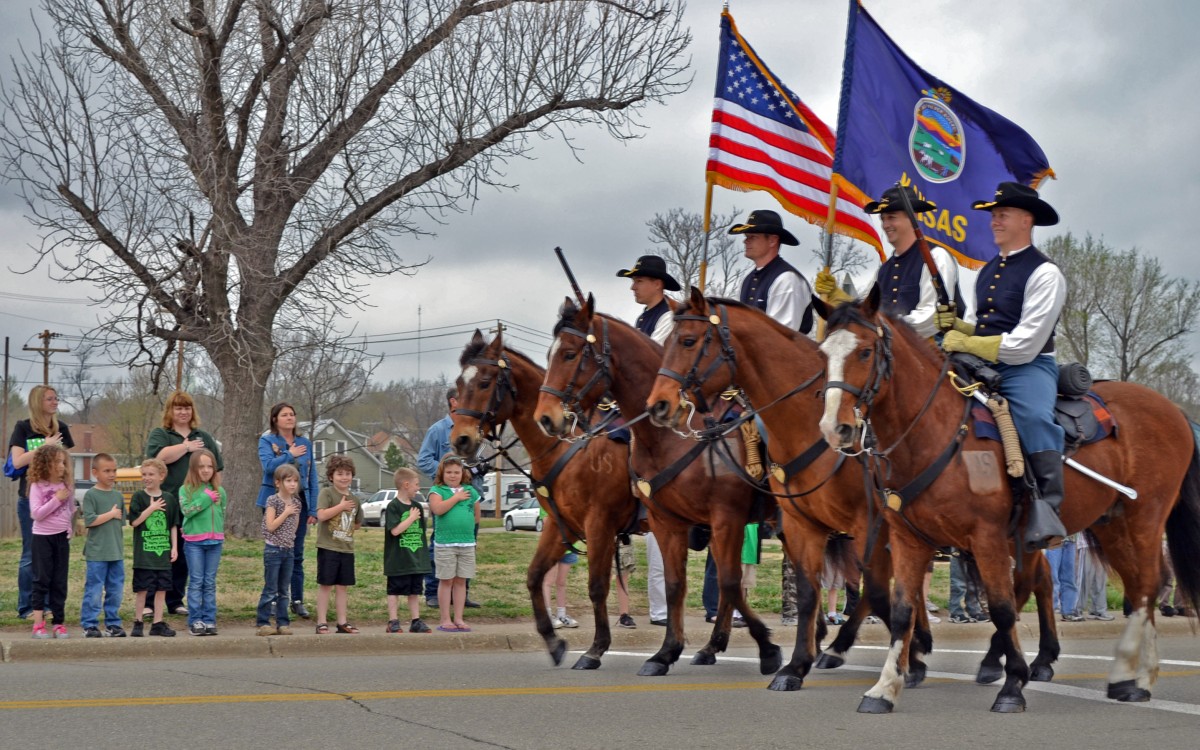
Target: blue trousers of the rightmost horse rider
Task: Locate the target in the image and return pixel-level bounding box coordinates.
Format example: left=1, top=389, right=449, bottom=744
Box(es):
left=992, top=354, right=1063, bottom=454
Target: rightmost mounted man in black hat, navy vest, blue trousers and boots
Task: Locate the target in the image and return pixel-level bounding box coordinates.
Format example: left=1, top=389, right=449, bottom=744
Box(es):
left=937, top=182, right=1067, bottom=548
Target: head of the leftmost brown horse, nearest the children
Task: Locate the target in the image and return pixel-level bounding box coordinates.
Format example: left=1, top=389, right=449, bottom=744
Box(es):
left=450, top=329, right=516, bottom=457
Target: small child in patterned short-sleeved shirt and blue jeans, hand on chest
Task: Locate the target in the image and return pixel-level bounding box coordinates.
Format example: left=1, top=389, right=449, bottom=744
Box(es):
left=256, top=463, right=306, bottom=636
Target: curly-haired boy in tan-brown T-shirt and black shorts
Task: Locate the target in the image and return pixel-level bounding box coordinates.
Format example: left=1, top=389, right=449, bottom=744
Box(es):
left=317, top=456, right=362, bottom=635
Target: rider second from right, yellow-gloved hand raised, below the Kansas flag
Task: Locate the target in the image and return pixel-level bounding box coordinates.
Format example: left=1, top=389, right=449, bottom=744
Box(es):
left=812, top=185, right=959, bottom=338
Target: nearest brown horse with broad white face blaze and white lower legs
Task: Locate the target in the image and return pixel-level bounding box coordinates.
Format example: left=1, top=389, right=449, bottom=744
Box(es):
left=815, top=288, right=1200, bottom=713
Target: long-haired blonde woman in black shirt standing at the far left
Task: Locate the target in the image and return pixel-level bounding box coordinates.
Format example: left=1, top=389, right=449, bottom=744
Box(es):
left=8, top=385, right=74, bottom=619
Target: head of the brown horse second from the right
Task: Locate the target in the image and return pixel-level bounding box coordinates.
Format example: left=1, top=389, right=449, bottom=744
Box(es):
left=646, top=287, right=737, bottom=428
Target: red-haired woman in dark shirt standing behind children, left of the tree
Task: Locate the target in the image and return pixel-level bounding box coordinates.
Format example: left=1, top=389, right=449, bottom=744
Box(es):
left=145, top=391, right=224, bottom=614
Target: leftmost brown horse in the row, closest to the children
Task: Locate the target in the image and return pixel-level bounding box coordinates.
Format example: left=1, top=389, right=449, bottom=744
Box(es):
left=450, top=331, right=637, bottom=670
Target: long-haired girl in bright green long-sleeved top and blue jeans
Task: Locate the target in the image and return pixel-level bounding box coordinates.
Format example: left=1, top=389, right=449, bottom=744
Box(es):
left=177, top=448, right=228, bottom=636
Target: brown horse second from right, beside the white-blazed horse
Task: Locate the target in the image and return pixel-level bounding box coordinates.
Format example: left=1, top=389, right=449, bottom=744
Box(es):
left=647, top=287, right=1058, bottom=686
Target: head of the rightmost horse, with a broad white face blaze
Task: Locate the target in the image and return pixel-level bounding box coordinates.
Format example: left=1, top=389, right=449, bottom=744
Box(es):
left=812, top=284, right=892, bottom=450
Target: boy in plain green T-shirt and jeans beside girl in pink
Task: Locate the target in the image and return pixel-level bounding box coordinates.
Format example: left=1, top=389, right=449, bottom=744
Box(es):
left=79, top=454, right=125, bottom=638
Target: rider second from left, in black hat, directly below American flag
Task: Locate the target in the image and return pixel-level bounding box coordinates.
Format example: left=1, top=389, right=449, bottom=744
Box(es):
left=730, top=210, right=812, bottom=334
